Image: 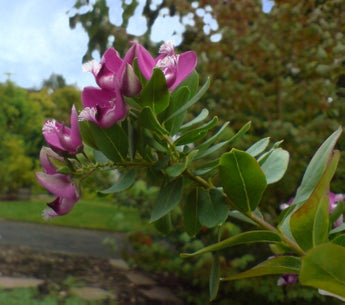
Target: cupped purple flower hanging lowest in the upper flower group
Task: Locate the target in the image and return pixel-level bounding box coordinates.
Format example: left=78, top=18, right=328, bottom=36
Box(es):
left=79, top=87, right=128, bottom=128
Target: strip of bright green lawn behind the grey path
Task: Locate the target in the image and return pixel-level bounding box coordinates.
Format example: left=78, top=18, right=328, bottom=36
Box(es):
left=0, top=199, right=152, bottom=232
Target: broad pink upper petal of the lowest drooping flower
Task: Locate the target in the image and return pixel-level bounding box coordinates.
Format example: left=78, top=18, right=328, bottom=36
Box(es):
left=36, top=172, right=76, bottom=198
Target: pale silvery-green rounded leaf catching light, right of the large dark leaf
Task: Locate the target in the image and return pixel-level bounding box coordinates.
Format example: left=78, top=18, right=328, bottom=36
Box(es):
left=261, top=148, right=289, bottom=184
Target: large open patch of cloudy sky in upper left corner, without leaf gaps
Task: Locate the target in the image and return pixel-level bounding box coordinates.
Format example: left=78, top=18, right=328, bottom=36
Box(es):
left=0, top=0, right=87, bottom=87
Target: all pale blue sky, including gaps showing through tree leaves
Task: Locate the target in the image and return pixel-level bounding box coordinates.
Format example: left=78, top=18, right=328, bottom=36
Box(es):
left=0, top=0, right=272, bottom=89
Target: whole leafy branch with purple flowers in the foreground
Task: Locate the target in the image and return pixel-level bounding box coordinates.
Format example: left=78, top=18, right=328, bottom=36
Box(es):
left=36, top=42, right=345, bottom=300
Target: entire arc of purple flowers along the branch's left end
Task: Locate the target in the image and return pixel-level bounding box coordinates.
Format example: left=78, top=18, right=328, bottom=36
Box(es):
left=36, top=42, right=197, bottom=218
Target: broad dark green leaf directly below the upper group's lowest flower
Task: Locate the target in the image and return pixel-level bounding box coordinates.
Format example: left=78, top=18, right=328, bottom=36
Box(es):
left=89, top=122, right=128, bottom=162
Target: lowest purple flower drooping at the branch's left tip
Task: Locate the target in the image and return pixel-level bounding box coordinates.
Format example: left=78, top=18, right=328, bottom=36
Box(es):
left=35, top=147, right=80, bottom=218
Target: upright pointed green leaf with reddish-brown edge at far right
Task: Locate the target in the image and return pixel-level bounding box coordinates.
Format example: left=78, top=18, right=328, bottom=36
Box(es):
left=290, top=151, right=340, bottom=250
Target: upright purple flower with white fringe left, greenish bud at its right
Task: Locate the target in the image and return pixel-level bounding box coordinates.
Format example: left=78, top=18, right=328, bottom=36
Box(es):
left=83, top=48, right=141, bottom=97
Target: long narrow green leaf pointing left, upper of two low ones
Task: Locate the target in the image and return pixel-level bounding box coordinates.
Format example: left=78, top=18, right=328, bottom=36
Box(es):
left=181, top=230, right=281, bottom=257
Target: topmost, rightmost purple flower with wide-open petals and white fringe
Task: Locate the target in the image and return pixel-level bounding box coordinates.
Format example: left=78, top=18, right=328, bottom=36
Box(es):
left=124, top=41, right=197, bottom=91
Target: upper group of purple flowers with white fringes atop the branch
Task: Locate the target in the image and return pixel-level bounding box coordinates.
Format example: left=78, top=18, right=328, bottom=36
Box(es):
left=79, top=42, right=197, bottom=128
